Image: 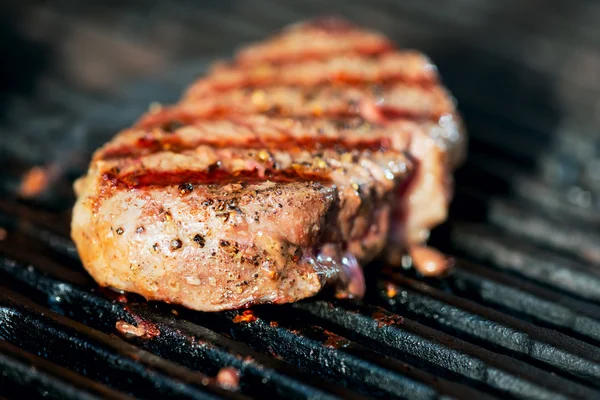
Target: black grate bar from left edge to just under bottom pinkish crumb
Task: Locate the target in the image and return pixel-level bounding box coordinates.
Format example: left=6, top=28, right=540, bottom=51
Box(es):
left=0, top=288, right=243, bottom=399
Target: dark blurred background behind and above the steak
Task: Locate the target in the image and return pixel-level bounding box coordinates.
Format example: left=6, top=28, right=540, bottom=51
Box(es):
left=0, top=0, right=600, bottom=214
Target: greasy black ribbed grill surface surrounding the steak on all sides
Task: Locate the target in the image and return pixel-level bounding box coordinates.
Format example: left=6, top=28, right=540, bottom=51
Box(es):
left=0, top=0, right=600, bottom=399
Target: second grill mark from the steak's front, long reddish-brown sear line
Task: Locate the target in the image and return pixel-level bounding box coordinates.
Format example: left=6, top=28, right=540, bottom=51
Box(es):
left=100, top=123, right=391, bottom=161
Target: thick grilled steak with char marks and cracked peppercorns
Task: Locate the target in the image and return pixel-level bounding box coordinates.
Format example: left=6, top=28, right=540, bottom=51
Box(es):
left=72, top=20, right=464, bottom=311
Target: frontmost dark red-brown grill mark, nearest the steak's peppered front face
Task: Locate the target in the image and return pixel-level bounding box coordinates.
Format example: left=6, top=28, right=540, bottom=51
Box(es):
left=101, top=166, right=331, bottom=189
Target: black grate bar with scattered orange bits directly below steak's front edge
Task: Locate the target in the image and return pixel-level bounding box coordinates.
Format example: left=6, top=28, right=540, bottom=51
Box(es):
left=192, top=306, right=496, bottom=398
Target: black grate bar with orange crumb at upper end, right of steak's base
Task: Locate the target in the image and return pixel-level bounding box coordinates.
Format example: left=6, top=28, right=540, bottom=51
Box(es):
left=378, top=273, right=600, bottom=385
